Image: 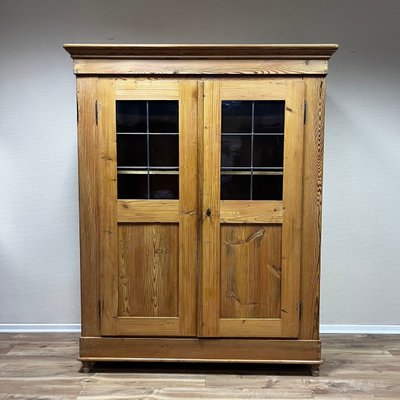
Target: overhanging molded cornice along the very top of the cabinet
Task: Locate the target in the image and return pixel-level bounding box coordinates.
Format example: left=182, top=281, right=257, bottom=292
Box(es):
left=63, top=43, right=339, bottom=60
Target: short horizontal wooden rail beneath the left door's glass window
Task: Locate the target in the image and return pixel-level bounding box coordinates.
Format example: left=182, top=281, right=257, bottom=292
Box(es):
left=117, top=200, right=180, bottom=223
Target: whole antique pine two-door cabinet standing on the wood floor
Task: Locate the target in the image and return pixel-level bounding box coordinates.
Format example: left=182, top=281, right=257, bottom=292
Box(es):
left=64, top=44, right=337, bottom=372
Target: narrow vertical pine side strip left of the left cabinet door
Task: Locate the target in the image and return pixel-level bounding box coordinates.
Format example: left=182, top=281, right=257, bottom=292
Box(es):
left=77, top=77, right=100, bottom=336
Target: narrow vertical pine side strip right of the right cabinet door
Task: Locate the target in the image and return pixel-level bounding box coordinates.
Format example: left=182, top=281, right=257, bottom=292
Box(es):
left=299, top=78, right=325, bottom=339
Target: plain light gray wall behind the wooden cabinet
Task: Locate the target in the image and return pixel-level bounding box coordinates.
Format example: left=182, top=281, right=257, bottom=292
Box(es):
left=0, top=0, right=400, bottom=324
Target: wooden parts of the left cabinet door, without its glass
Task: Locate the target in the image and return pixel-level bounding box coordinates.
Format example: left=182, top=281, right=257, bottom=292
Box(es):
left=98, top=78, right=198, bottom=336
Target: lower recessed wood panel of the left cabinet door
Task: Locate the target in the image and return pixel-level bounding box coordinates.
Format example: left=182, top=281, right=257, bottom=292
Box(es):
left=118, top=224, right=179, bottom=317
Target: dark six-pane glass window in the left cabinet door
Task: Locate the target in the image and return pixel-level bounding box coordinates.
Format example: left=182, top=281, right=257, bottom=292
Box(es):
left=116, top=100, right=179, bottom=199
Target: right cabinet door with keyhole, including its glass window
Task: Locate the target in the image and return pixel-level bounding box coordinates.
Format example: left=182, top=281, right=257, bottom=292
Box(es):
left=199, top=78, right=304, bottom=338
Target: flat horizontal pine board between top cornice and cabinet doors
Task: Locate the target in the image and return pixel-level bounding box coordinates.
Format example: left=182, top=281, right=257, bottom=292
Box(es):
left=74, top=59, right=328, bottom=76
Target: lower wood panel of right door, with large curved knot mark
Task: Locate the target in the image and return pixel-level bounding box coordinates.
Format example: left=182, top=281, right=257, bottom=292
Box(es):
left=221, top=225, right=282, bottom=318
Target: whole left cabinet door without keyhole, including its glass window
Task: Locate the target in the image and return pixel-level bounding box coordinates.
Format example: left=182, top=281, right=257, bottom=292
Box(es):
left=98, top=78, right=197, bottom=336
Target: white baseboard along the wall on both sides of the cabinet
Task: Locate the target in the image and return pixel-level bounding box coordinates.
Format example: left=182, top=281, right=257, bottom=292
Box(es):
left=0, top=324, right=400, bottom=334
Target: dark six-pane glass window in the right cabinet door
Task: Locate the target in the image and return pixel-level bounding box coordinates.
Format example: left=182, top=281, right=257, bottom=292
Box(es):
left=221, top=100, right=285, bottom=200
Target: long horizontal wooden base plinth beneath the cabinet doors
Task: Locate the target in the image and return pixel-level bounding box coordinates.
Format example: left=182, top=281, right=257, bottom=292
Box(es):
left=79, top=337, right=322, bottom=365
